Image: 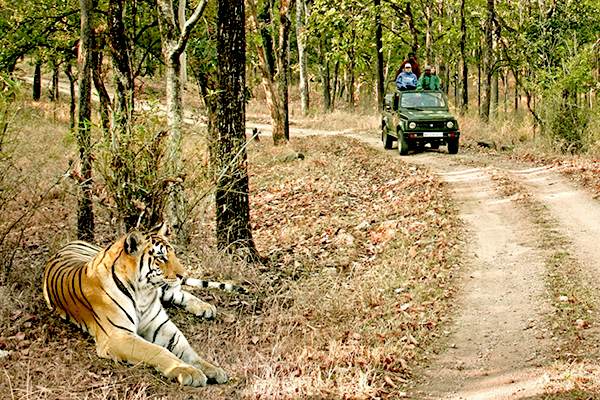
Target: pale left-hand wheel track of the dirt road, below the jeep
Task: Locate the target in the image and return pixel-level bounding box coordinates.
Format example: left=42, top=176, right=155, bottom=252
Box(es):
left=409, top=161, right=550, bottom=399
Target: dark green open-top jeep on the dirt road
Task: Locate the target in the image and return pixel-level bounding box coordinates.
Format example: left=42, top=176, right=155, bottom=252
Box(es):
left=381, top=90, right=460, bottom=155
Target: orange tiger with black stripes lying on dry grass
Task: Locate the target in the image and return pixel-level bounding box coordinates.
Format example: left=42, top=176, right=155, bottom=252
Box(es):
left=43, top=224, right=236, bottom=387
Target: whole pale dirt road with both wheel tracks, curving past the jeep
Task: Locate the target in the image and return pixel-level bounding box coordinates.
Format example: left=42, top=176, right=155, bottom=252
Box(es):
left=332, top=130, right=600, bottom=400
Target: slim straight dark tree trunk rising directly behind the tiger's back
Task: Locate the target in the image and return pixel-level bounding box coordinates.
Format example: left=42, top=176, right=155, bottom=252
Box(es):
left=77, top=0, right=94, bottom=242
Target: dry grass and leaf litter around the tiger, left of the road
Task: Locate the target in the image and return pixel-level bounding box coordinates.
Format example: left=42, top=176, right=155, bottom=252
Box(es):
left=0, top=92, right=460, bottom=399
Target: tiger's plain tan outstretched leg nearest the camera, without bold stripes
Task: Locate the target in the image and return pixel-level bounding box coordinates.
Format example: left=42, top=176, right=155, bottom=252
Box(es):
left=96, top=331, right=207, bottom=387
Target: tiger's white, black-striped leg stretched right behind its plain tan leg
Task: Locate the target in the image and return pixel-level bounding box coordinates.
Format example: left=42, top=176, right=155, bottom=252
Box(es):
left=140, top=310, right=229, bottom=383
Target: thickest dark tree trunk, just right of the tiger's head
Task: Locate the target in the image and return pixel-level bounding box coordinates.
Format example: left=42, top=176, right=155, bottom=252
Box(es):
left=210, top=0, right=258, bottom=259
